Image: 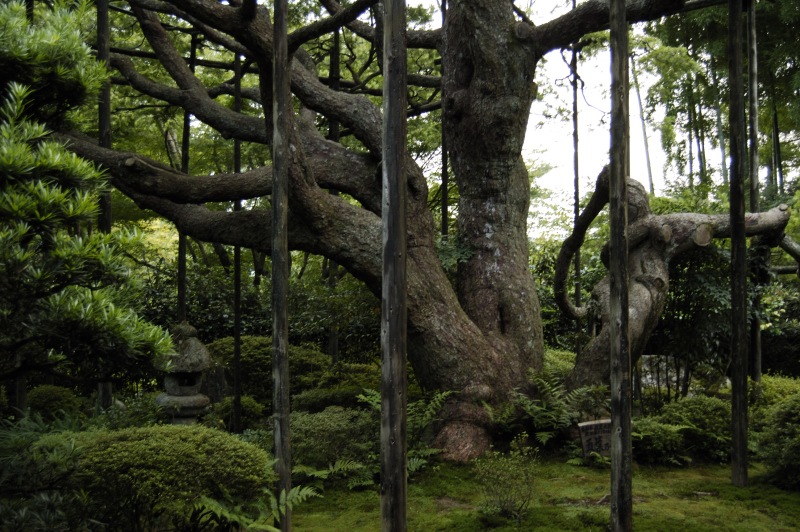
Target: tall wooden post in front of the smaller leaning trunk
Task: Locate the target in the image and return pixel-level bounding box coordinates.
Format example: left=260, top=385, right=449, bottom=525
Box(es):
left=609, top=0, right=633, bottom=532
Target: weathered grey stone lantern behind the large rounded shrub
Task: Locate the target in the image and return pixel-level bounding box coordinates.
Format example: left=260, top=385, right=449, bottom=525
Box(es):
left=156, top=321, right=211, bottom=425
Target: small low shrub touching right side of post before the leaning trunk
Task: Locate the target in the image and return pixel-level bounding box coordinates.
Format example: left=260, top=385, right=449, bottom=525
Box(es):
left=632, top=418, right=690, bottom=465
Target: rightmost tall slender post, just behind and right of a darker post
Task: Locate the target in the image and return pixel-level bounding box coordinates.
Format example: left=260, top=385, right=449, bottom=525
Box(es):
left=747, top=0, right=769, bottom=384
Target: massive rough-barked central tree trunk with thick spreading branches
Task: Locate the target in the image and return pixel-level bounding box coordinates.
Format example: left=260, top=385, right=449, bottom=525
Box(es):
left=64, top=0, right=752, bottom=459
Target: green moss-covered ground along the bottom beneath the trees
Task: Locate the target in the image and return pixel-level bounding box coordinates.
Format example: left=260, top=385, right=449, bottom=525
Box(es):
left=292, top=459, right=800, bottom=532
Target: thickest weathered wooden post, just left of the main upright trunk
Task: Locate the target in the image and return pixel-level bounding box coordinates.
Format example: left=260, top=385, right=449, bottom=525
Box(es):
left=381, top=0, right=407, bottom=532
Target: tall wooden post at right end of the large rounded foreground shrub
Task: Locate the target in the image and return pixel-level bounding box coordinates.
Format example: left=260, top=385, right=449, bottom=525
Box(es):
left=272, top=0, right=292, bottom=532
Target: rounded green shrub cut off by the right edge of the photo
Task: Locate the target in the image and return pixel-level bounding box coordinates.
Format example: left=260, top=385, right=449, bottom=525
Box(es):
left=758, top=393, right=800, bottom=490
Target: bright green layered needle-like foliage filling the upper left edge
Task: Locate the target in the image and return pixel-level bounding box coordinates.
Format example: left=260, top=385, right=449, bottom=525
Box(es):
left=0, top=2, right=171, bottom=390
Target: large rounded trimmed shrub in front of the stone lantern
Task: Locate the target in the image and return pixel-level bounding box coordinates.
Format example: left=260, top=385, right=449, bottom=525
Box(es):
left=37, top=425, right=272, bottom=532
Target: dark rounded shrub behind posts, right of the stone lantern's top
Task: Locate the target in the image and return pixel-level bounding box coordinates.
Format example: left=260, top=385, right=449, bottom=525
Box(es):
left=206, top=336, right=330, bottom=412
